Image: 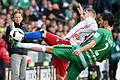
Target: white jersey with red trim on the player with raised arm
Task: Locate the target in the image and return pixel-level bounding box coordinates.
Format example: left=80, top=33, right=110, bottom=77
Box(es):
left=64, top=17, right=98, bottom=45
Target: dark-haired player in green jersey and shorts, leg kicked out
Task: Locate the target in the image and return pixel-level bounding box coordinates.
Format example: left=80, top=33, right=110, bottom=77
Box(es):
left=14, top=13, right=114, bottom=80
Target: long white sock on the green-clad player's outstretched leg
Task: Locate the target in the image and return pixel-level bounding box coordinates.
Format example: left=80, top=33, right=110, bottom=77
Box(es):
left=17, top=43, right=46, bottom=52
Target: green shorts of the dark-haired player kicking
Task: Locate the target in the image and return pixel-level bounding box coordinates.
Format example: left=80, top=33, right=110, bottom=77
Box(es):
left=53, top=44, right=84, bottom=80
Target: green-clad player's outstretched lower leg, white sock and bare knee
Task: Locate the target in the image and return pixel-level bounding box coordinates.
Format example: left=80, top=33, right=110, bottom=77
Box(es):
left=17, top=43, right=53, bottom=54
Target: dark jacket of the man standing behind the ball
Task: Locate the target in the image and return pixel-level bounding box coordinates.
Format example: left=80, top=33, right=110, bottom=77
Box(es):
left=6, top=22, right=30, bottom=56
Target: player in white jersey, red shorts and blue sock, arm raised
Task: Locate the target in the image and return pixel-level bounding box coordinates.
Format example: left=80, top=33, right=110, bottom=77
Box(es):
left=24, top=5, right=98, bottom=80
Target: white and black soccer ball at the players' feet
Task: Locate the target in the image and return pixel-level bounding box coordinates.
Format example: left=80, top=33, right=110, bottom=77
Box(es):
left=10, top=28, right=24, bottom=42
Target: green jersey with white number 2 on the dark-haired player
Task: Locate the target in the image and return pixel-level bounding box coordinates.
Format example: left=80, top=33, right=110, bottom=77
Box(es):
left=79, top=28, right=113, bottom=67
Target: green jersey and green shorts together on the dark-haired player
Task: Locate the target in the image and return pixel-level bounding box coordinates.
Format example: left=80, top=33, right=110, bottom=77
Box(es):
left=53, top=28, right=113, bottom=80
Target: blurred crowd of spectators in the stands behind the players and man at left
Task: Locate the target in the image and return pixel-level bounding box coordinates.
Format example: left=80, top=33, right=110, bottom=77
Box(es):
left=0, top=0, right=120, bottom=78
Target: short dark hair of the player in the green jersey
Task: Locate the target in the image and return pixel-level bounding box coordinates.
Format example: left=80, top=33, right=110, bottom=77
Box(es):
left=102, top=13, right=114, bottom=27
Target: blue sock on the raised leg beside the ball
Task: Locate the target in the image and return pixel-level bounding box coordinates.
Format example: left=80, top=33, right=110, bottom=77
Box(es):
left=24, top=31, right=42, bottom=39
